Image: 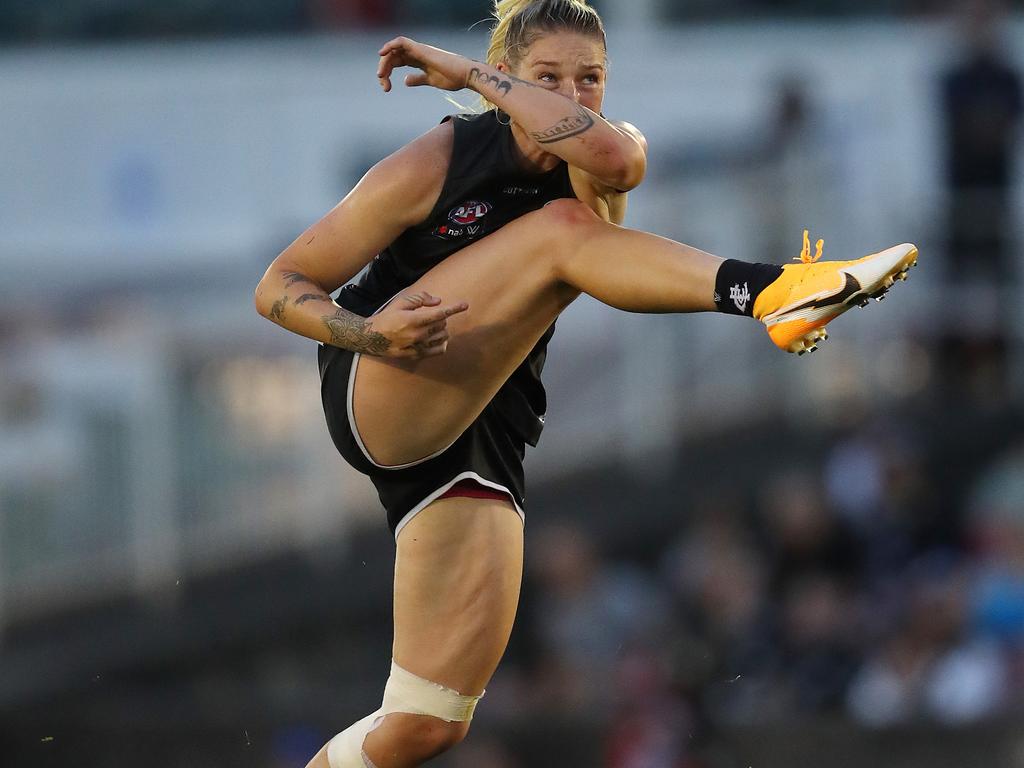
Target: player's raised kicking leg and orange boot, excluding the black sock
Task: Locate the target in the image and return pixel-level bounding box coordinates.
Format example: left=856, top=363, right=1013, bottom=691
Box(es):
left=353, top=200, right=918, bottom=465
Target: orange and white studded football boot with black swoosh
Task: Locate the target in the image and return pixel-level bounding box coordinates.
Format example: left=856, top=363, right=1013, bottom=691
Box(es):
left=754, top=229, right=918, bottom=354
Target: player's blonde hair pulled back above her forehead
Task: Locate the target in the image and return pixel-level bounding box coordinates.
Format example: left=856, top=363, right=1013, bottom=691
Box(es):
left=481, top=0, right=606, bottom=109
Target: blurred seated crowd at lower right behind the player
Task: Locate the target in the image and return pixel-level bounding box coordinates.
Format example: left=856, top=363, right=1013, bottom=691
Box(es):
left=454, top=399, right=1024, bottom=768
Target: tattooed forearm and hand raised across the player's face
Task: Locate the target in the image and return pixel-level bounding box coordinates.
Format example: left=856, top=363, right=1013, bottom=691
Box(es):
left=377, top=37, right=647, bottom=191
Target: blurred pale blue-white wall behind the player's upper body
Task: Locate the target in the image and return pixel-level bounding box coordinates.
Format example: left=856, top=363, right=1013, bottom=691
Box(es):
left=0, top=23, right=1007, bottom=293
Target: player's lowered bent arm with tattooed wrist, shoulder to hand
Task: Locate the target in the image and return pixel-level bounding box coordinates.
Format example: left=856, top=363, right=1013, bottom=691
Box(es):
left=255, top=124, right=466, bottom=357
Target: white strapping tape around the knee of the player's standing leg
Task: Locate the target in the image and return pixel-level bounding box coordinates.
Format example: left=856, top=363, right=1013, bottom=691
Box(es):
left=327, top=662, right=483, bottom=768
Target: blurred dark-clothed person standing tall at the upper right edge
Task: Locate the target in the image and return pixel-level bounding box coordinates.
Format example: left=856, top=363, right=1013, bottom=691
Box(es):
left=940, top=0, right=1022, bottom=399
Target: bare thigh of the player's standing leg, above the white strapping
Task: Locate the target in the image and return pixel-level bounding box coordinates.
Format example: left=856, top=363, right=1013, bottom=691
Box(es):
left=364, top=499, right=522, bottom=761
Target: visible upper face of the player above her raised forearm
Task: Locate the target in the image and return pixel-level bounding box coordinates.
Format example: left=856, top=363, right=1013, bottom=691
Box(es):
left=512, top=32, right=607, bottom=112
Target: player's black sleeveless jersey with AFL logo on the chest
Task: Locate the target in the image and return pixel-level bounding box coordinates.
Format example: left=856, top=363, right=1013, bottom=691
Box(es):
left=338, top=112, right=575, bottom=445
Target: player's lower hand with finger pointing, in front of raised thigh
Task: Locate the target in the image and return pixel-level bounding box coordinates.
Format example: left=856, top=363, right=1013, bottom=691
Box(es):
left=367, top=291, right=469, bottom=358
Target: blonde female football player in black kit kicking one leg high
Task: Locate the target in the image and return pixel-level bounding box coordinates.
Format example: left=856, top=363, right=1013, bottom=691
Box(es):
left=256, top=0, right=916, bottom=768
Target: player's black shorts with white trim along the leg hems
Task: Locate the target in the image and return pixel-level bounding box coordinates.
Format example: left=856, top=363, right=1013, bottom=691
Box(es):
left=317, top=344, right=526, bottom=537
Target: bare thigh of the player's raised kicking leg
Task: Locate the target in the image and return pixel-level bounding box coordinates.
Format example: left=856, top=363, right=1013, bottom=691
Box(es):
left=353, top=204, right=579, bottom=466
